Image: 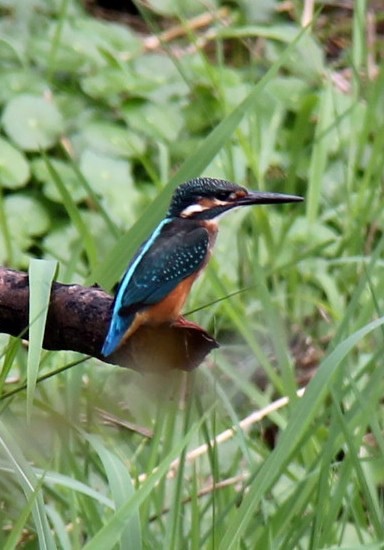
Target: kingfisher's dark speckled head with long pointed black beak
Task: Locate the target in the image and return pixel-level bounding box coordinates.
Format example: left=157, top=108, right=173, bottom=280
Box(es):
left=168, top=177, right=303, bottom=220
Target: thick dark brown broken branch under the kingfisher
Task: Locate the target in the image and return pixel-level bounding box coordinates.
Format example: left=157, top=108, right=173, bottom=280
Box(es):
left=0, top=267, right=218, bottom=371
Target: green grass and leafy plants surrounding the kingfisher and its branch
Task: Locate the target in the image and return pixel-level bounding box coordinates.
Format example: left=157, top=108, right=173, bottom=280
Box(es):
left=0, top=0, right=384, bottom=550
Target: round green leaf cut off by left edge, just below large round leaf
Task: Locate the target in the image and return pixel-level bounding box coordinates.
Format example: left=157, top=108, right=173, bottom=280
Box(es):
left=0, top=138, right=29, bottom=189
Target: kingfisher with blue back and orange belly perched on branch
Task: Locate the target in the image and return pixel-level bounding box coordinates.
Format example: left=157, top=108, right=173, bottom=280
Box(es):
left=102, top=177, right=303, bottom=357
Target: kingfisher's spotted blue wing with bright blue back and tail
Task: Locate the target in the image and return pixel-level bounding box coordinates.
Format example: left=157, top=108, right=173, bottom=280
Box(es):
left=102, top=220, right=209, bottom=356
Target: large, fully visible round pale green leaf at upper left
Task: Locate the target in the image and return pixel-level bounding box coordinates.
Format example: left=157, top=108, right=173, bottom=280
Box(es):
left=2, top=94, right=64, bottom=151
